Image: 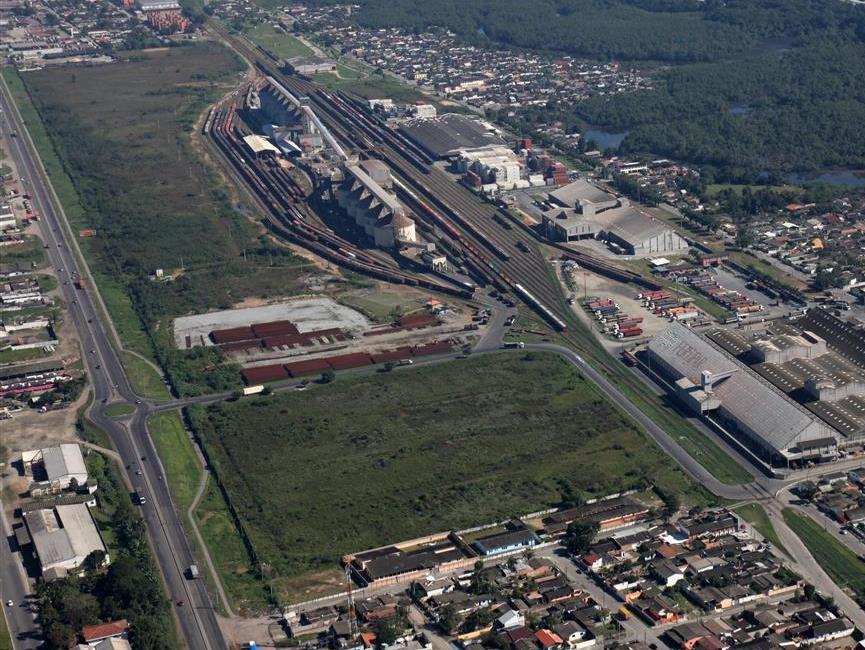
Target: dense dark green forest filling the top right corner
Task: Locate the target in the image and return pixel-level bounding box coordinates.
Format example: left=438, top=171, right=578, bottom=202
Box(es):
left=348, top=0, right=865, bottom=180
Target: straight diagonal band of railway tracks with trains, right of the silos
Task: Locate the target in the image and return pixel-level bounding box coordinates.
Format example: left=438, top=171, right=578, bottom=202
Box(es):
left=214, top=25, right=656, bottom=330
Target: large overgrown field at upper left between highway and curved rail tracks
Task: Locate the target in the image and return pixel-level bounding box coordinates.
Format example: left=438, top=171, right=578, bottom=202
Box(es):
left=12, top=42, right=340, bottom=390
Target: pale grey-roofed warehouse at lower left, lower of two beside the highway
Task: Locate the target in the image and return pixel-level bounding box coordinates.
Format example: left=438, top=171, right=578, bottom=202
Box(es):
left=23, top=503, right=108, bottom=577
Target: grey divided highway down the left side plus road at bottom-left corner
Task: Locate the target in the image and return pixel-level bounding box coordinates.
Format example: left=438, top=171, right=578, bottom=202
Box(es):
left=0, top=77, right=227, bottom=650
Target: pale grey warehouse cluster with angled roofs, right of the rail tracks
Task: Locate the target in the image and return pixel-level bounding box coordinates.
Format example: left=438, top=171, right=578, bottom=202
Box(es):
left=544, top=179, right=688, bottom=256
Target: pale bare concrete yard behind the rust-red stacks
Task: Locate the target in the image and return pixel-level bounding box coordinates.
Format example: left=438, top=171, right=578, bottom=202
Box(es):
left=174, top=298, right=371, bottom=349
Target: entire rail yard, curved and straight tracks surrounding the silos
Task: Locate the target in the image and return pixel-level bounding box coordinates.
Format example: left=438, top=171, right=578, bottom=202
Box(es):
left=205, top=28, right=654, bottom=331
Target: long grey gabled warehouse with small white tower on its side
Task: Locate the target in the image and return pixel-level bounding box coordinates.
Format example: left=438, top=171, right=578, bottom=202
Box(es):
left=649, top=323, right=840, bottom=464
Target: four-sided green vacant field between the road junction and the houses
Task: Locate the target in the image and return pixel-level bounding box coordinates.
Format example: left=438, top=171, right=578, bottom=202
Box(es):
left=191, top=354, right=704, bottom=600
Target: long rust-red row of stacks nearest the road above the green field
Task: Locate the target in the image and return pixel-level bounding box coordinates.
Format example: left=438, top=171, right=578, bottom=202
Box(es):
left=241, top=341, right=453, bottom=385
